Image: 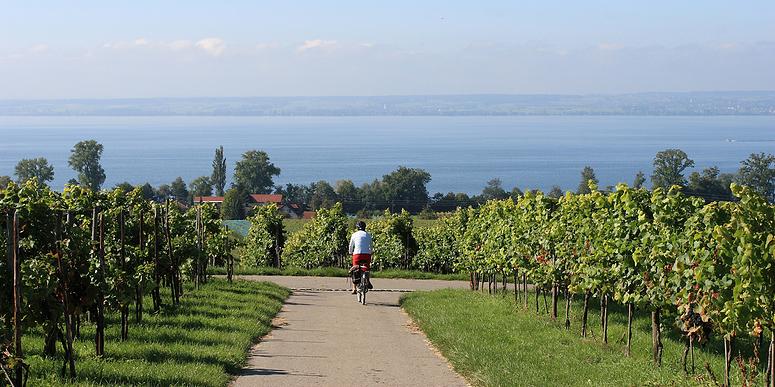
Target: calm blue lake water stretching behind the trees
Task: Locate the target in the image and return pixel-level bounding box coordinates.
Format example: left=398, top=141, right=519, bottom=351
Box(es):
left=0, top=116, right=775, bottom=193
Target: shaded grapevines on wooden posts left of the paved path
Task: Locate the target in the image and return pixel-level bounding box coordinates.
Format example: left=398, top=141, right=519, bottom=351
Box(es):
left=0, top=179, right=231, bottom=386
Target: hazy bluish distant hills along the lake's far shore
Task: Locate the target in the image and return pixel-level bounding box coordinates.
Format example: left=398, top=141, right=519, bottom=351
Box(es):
left=0, top=91, right=775, bottom=116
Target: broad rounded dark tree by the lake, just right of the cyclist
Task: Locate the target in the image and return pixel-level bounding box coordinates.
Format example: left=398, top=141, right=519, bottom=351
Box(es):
left=382, top=166, right=431, bottom=212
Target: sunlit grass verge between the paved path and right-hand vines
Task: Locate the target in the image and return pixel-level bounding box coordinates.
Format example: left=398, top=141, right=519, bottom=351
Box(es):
left=401, top=290, right=766, bottom=386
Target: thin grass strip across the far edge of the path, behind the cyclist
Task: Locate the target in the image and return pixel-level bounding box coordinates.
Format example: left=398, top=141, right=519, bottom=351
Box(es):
left=208, top=266, right=468, bottom=280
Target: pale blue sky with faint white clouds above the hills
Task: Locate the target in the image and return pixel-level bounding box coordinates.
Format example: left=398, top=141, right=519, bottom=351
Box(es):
left=0, top=0, right=775, bottom=99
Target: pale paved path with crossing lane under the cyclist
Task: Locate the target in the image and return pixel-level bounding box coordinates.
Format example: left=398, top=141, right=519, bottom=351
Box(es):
left=232, top=276, right=468, bottom=387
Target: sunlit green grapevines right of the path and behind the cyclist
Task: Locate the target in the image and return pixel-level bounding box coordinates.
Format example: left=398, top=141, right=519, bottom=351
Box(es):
left=244, top=185, right=775, bottom=386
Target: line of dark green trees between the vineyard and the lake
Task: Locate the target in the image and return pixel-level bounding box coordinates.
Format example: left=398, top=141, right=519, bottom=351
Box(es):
left=0, top=140, right=775, bottom=219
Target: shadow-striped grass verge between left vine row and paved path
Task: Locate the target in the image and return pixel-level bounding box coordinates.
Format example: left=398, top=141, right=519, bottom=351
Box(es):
left=24, top=279, right=289, bottom=386
